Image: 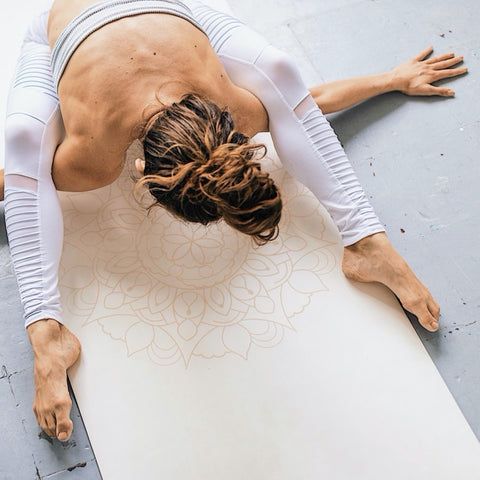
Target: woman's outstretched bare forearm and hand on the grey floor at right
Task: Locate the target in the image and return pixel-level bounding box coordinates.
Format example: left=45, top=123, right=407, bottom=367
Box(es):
left=310, top=46, right=467, bottom=114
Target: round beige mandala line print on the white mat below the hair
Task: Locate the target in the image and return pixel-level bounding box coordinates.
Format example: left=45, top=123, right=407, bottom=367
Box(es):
left=60, top=139, right=335, bottom=366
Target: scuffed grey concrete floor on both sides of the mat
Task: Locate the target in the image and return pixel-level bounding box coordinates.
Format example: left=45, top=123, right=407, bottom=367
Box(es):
left=0, top=0, right=480, bottom=480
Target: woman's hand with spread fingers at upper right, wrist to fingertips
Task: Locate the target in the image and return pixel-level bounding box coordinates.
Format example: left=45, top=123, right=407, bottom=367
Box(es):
left=391, top=47, right=468, bottom=97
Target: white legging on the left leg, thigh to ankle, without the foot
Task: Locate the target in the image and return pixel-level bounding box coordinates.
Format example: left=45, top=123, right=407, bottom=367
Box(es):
left=5, top=10, right=63, bottom=326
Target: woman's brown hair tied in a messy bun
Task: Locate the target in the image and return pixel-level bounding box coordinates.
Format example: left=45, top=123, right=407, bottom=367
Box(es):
left=137, top=94, right=282, bottom=244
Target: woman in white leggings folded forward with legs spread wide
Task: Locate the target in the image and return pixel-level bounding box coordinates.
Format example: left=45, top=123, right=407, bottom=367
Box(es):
left=0, top=0, right=466, bottom=440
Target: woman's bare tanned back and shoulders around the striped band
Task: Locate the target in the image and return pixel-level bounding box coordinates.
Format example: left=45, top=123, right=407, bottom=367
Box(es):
left=48, top=0, right=266, bottom=190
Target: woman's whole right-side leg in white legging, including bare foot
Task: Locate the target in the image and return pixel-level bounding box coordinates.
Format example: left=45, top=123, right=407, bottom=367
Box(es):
left=188, top=3, right=439, bottom=330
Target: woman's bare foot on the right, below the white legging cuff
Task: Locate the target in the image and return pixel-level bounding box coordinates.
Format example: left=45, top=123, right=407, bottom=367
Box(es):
left=342, top=233, right=440, bottom=332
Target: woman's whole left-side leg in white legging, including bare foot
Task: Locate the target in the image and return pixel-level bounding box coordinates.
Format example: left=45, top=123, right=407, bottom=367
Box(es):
left=5, top=9, right=80, bottom=440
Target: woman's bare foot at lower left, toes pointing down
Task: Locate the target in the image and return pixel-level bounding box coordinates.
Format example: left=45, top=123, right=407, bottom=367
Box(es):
left=27, top=319, right=80, bottom=441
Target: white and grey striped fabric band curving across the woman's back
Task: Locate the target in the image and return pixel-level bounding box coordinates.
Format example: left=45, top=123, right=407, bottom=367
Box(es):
left=52, top=0, right=203, bottom=90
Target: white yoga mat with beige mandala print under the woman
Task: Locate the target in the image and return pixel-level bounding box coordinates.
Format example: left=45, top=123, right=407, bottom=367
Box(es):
left=2, top=0, right=480, bottom=480
